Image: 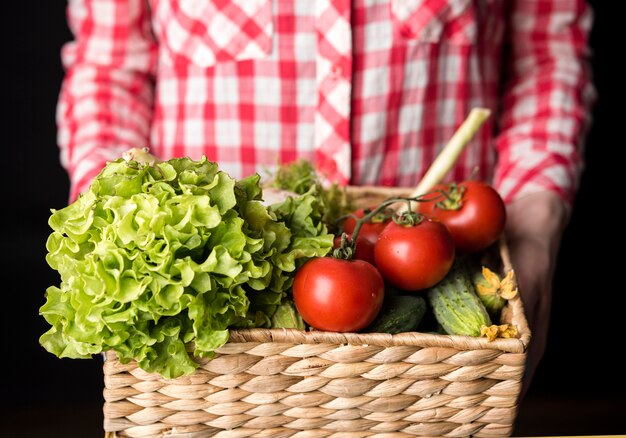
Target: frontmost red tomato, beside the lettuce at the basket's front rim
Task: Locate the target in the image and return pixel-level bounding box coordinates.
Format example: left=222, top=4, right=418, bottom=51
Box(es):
left=293, top=257, right=385, bottom=332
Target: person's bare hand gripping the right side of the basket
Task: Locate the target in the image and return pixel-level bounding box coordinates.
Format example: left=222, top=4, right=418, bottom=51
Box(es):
left=506, top=192, right=568, bottom=399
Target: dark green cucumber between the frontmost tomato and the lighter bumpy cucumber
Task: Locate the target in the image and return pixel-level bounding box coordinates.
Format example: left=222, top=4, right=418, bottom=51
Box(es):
left=365, top=295, right=426, bottom=335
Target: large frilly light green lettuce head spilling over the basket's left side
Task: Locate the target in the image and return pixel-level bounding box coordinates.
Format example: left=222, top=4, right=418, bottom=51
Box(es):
left=40, top=157, right=333, bottom=378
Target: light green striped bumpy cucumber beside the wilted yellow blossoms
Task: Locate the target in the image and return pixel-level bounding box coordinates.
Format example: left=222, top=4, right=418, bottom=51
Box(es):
left=428, top=262, right=491, bottom=336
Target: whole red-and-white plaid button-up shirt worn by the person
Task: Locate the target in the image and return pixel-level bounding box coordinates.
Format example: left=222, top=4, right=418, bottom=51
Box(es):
left=58, top=0, right=593, bottom=202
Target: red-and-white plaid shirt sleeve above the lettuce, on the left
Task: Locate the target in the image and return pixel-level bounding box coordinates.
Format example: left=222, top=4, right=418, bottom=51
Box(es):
left=57, top=0, right=156, bottom=201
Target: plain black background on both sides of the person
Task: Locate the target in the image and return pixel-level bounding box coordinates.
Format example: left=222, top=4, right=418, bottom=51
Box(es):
left=0, top=0, right=626, bottom=437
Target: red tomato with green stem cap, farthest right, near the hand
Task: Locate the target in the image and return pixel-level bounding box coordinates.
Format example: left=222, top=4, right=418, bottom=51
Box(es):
left=418, top=181, right=506, bottom=253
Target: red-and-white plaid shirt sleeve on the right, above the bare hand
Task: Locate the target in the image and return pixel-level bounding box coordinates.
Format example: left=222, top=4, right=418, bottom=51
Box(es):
left=495, top=0, right=595, bottom=204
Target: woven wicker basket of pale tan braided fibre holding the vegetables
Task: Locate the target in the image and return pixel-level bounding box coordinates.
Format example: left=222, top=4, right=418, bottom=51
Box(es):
left=104, top=188, right=530, bottom=438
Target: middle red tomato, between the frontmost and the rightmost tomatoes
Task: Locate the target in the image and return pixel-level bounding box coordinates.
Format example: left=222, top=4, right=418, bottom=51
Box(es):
left=374, top=218, right=454, bottom=291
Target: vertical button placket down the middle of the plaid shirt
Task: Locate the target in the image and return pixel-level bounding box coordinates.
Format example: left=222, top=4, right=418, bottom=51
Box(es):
left=315, top=0, right=352, bottom=184
